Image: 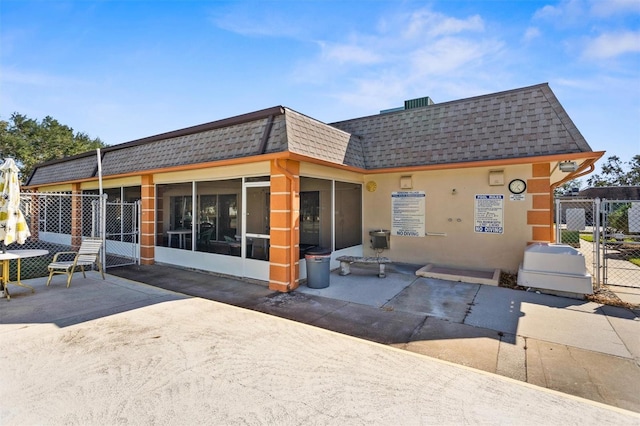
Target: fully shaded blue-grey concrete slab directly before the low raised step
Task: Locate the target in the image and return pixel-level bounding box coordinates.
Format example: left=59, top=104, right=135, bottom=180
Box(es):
left=384, top=278, right=480, bottom=323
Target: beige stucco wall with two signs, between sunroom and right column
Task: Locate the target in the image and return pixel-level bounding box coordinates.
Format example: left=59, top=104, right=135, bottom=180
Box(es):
left=363, top=165, right=532, bottom=272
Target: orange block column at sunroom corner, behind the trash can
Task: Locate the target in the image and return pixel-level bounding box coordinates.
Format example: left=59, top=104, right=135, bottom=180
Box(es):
left=269, top=160, right=300, bottom=292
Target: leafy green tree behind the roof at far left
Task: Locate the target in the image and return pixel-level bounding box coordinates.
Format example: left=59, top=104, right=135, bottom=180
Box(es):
left=0, top=112, right=105, bottom=181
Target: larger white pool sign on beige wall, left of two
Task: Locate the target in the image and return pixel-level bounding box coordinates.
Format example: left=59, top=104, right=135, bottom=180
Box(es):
left=391, top=191, right=426, bottom=237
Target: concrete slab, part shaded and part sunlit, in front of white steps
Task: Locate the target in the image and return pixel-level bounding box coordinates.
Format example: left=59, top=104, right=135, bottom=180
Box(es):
left=465, top=286, right=632, bottom=358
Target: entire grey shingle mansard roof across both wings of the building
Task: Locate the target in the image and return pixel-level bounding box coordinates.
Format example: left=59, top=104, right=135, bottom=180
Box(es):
left=27, top=84, right=591, bottom=186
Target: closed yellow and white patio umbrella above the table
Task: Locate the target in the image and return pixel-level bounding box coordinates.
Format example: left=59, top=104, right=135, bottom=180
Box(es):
left=0, top=158, right=31, bottom=245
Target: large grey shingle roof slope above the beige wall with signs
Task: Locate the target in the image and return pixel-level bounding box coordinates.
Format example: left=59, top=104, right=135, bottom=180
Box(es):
left=332, top=84, right=591, bottom=169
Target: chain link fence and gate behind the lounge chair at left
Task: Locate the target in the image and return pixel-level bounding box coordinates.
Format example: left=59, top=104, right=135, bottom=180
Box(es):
left=6, top=192, right=139, bottom=282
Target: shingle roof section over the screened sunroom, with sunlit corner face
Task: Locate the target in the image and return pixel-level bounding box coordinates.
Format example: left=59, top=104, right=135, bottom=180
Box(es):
left=27, top=107, right=364, bottom=185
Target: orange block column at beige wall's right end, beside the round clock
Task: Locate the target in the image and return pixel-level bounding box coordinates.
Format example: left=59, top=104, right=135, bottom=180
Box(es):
left=527, top=163, right=553, bottom=243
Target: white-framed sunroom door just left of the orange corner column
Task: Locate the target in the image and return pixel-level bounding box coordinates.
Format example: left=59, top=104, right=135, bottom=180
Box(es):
left=240, top=178, right=271, bottom=281
